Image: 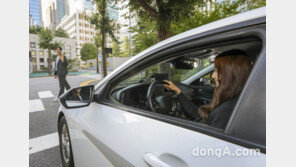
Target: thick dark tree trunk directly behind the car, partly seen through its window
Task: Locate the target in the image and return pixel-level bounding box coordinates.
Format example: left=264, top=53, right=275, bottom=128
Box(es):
left=157, top=20, right=171, bottom=74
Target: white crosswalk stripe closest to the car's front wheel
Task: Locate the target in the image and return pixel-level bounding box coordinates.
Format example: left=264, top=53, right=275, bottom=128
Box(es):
left=29, top=133, right=59, bottom=154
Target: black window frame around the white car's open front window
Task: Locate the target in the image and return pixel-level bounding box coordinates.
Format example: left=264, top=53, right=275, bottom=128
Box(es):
left=97, top=17, right=266, bottom=154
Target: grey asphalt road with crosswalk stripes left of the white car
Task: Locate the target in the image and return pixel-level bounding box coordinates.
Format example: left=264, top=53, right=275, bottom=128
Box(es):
left=29, top=75, right=98, bottom=167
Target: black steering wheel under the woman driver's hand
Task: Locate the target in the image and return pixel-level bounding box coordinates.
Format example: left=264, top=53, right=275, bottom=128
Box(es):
left=146, top=81, right=181, bottom=116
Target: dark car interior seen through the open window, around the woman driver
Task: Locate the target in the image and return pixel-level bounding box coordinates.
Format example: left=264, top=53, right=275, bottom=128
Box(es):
left=109, top=37, right=263, bottom=127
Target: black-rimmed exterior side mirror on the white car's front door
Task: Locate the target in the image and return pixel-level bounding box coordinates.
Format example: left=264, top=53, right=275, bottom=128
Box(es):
left=60, top=85, right=94, bottom=109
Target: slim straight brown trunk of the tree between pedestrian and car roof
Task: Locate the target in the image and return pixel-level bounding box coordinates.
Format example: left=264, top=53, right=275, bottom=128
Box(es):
left=101, top=0, right=107, bottom=78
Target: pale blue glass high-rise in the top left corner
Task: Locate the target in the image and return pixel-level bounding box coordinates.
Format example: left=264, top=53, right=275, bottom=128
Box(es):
left=29, top=0, right=43, bottom=26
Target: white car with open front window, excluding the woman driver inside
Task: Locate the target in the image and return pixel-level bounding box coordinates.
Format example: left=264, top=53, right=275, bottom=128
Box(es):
left=58, top=8, right=266, bottom=167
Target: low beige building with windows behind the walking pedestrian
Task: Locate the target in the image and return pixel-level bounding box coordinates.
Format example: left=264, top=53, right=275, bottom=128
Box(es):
left=29, top=34, right=77, bottom=72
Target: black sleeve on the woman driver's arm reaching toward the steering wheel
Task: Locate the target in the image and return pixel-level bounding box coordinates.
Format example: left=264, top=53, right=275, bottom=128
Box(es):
left=178, top=92, right=201, bottom=120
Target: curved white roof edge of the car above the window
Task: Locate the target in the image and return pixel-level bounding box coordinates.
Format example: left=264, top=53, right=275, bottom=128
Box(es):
left=96, top=7, right=266, bottom=88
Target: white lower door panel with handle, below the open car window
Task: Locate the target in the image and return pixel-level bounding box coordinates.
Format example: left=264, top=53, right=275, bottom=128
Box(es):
left=73, top=88, right=265, bottom=167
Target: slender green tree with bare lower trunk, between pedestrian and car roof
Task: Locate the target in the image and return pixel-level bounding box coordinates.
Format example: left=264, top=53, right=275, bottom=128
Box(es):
left=88, top=0, right=117, bottom=77
